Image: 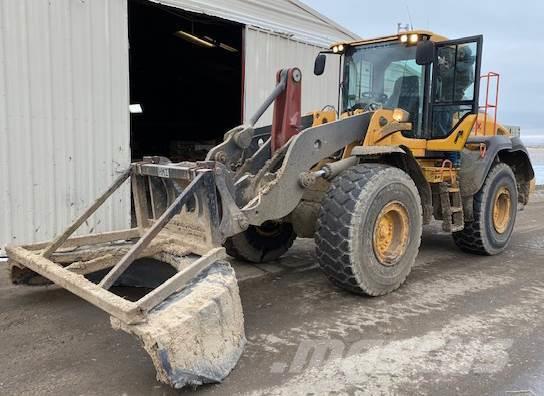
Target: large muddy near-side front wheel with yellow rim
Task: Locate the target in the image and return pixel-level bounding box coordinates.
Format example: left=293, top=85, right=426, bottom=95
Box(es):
left=315, top=164, right=422, bottom=296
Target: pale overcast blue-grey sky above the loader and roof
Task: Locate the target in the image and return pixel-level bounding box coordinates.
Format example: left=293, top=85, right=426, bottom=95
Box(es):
left=304, top=0, right=544, bottom=132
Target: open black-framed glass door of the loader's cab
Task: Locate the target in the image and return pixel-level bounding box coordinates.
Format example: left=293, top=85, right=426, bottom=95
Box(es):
left=427, top=35, right=483, bottom=139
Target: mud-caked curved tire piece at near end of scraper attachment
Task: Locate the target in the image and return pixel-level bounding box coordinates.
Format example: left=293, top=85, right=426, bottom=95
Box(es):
left=111, top=261, right=246, bottom=389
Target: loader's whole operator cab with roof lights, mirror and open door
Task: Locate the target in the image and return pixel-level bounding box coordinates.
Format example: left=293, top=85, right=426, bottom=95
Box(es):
left=314, top=31, right=482, bottom=139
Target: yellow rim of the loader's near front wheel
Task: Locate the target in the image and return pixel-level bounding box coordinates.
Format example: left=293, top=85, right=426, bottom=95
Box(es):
left=373, top=201, right=410, bottom=266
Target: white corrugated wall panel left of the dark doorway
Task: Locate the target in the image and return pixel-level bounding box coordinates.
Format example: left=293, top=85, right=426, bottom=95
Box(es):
left=0, top=0, right=130, bottom=248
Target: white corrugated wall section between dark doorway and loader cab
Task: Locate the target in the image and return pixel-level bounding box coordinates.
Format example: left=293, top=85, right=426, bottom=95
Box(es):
left=244, top=27, right=339, bottom=125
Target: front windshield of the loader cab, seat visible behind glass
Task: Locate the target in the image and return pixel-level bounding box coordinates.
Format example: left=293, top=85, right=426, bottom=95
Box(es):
left=342, top=42, right=425, bottom=134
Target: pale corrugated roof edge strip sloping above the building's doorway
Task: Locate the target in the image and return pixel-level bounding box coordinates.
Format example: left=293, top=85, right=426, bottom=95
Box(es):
left=151, top=0, right=358, bottom=47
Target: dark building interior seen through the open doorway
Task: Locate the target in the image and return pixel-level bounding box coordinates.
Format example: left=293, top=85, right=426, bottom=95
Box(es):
left=128, top=0, right=243, bottom=161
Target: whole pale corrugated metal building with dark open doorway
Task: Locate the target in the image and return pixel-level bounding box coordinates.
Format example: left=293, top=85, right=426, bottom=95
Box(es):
left=0, top=0, right=357, bottom=249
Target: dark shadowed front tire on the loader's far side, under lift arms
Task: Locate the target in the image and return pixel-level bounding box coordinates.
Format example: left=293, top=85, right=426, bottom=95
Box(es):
left=224, top=221, right=297, bottom=263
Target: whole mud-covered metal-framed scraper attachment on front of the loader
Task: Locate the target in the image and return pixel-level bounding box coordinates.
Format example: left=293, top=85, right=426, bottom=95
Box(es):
left=6, top=158, right=245, bottom=388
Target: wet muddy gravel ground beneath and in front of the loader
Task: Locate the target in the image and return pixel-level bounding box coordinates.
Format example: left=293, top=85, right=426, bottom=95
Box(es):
left=0, top=195, right=544, bottom=395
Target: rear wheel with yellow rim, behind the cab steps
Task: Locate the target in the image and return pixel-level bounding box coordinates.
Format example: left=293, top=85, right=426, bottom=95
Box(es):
left=453, top=164, right=518, bottom=255
